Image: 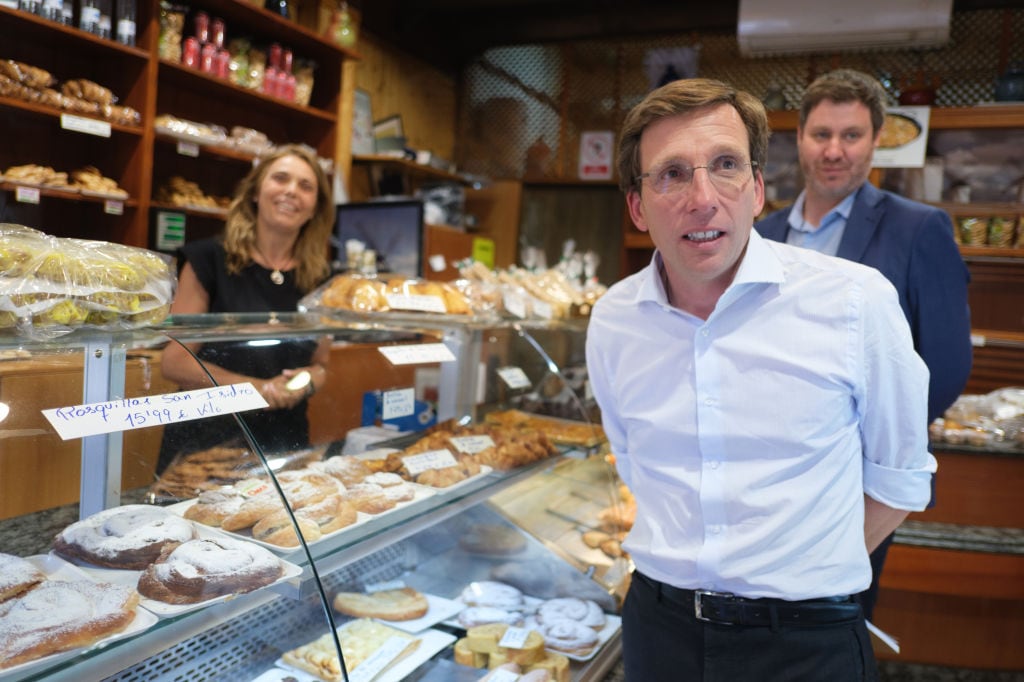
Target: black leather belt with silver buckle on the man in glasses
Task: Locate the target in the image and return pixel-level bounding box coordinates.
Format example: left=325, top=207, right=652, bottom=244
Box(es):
left=633, top=571, right=860, bottom=627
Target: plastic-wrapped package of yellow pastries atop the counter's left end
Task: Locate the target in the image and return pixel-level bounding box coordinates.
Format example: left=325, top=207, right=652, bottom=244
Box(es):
left=0, top=223, right=176, bottom=338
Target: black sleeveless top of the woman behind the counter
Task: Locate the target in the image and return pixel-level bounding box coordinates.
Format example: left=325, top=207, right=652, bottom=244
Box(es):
left=157, top=238, right=318, bottom=474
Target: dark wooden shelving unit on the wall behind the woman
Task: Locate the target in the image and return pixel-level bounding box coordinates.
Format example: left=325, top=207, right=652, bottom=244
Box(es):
left=0, top=0, right=358, bottom=248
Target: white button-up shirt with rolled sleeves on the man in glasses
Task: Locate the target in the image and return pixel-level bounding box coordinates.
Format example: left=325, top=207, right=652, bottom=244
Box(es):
left=587, top=230, right=936, bottom=599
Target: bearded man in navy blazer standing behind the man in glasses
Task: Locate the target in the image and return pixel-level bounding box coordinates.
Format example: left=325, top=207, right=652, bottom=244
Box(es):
left=756, top=69, right=973, bottom=620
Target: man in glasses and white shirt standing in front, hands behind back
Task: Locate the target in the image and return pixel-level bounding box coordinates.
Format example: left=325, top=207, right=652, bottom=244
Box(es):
left=587, top=79, right=935, bottom=682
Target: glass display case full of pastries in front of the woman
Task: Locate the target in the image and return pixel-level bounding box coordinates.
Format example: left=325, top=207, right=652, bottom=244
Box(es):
left=0, top=313, right=629, bottom=682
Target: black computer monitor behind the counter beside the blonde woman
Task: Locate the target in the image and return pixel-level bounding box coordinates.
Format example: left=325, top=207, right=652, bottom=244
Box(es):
left=335, top=199, right=423, bottom=276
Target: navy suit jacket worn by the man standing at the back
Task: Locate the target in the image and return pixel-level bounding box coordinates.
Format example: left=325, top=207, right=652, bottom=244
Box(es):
left=755, top=182, right=973, bottom=423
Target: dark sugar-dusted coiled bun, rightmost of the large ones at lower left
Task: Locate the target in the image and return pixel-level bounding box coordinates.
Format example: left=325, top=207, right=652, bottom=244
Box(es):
left=138, top=538, right=282, bottom=604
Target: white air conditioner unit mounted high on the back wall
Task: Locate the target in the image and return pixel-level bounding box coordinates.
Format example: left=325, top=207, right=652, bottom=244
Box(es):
left=736, top=0, right=953, bottom=56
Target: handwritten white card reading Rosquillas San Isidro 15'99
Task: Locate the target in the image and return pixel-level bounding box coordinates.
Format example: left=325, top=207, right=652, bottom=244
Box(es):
left=42, top=383, right=267, bottom=440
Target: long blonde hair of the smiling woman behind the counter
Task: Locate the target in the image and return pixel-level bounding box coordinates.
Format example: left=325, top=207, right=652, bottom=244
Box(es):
left=224, top=144, right=334, bottom=292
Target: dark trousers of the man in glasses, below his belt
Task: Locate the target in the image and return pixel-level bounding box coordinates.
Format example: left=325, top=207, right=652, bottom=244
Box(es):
left=623, top=573, right=879, bottom=682
